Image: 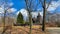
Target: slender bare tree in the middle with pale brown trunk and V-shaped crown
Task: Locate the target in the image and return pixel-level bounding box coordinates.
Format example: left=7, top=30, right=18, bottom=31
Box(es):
left=25, top=0, right=32, bottom=34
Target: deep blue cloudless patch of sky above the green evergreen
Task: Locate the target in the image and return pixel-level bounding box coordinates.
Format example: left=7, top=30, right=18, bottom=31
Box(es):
left=12, top=0, right=25, bottom=10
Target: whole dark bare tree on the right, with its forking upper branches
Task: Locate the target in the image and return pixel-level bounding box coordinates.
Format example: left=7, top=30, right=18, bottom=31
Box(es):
left=39, top=0, right=52, bottom=31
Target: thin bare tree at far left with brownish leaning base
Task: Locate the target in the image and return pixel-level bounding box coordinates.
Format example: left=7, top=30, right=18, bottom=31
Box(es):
left=0, top=0, right=12, bottom=34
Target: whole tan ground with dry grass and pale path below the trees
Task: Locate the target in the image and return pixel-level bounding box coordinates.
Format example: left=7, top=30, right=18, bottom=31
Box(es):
left=0, top=25, right=60, bottom=34
